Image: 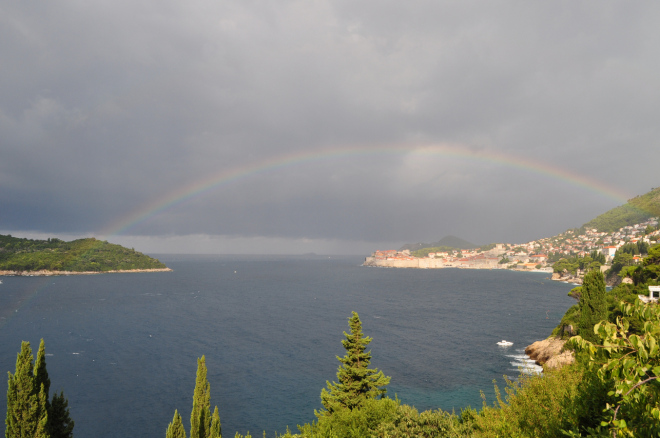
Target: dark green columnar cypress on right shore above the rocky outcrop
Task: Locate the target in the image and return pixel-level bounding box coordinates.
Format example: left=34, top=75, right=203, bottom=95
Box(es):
left=578, top=269, right=607, bottom=342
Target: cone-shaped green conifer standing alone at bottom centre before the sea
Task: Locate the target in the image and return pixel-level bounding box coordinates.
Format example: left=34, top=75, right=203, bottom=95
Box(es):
left=317, top=312, right=390, bottom=417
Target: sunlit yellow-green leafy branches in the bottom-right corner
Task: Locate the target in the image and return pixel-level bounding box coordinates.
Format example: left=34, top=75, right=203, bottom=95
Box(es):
left=571, top=301, right=660, bottom=436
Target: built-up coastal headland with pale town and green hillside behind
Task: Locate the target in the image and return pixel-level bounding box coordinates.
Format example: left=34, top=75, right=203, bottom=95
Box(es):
left=364, top=188, right=660, bottom=284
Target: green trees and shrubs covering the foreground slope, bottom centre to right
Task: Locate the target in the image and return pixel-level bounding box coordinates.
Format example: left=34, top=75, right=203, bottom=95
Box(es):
left=156, top=241, right=660, bottom=438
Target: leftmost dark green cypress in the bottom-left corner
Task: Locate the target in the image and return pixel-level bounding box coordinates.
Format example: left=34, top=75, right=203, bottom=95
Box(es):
left=5, top=341, right=50, bottom=438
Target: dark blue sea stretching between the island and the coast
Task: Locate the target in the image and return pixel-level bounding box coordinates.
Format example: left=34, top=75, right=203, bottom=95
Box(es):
left=0, top=256, right=573, bottom=437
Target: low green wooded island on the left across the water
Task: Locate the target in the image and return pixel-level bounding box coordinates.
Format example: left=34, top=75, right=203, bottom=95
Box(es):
left=0, top=234, right=167, bottom=272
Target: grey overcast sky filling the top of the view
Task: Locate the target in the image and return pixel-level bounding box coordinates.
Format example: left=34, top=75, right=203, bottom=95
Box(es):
left=0, top=0, right=660, bottom=254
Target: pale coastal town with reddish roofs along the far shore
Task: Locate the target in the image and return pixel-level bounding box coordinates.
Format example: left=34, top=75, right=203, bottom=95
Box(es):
left=364, top=217, right=660, bottom=279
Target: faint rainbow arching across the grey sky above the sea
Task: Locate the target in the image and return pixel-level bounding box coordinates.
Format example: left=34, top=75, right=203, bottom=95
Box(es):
left=99, top=145, right=631, bottom=236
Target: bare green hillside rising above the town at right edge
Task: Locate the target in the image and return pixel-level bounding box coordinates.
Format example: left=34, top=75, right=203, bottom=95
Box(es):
left=583, top=187, right=660, bottom=233
